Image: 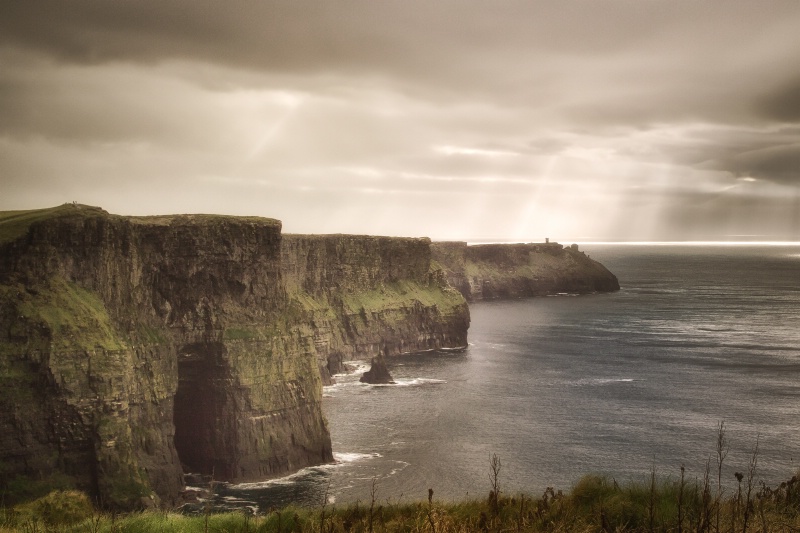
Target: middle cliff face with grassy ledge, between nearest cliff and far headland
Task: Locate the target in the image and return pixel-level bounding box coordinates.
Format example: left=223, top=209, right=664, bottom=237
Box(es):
left=281, top=235, right=469, bottom=376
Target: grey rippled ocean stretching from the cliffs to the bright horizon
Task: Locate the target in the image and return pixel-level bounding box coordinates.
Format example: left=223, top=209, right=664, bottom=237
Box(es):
left=198, top=245, right=800, bottom=512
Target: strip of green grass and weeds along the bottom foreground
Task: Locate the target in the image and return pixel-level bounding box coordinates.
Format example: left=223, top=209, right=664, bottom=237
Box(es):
left=0, top=475, right=800, bottom=533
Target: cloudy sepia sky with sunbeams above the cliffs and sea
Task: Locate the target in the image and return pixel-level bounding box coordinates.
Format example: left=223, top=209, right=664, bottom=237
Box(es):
left=0, top=0, right=800, bottom=242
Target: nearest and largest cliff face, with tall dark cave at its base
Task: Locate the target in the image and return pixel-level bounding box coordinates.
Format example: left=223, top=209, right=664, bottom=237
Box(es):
left=0, top=208, right=332, bottom=507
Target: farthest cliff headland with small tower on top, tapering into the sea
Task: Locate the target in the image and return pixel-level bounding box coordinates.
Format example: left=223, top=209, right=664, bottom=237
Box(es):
left=431, top=242, right=619, bottom=301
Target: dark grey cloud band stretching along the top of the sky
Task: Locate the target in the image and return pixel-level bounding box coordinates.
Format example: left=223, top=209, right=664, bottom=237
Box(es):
left=6, top=0, right=797, bottom=110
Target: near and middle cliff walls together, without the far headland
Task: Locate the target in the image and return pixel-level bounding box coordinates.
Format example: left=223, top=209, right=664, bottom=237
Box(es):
left=0, top=205, right=469, bottom=508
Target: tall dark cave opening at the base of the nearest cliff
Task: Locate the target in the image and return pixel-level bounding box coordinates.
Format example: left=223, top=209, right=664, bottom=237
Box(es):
left=173, top=343, right=236, bottom=480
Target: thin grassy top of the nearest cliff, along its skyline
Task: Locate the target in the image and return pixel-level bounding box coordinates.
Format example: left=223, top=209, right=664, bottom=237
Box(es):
left=0, top=203, right=281, bottom=244
